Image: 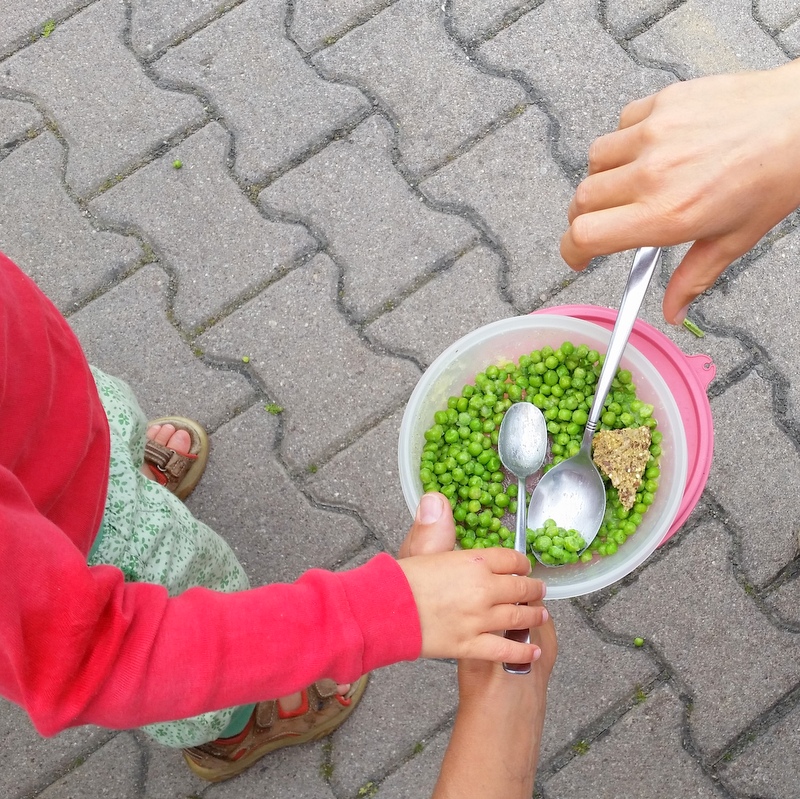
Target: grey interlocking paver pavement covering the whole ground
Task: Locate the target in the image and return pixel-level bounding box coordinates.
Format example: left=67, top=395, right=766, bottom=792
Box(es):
left=0, top=0, right=800, bottom=799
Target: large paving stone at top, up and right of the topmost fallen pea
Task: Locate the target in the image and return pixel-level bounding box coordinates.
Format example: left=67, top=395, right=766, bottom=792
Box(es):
left=155, top=0, right=370, bottom=182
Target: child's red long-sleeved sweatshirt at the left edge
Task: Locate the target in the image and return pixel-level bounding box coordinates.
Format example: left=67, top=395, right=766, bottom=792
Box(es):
left=0, top=253, right=421, bottom=735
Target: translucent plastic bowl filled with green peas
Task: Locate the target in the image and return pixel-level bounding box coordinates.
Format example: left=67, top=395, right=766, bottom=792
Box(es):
left=398, top=314, right=688, bottom=599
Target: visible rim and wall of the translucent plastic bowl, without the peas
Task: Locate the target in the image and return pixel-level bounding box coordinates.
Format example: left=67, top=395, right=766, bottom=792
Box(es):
left=398, top=314, right=688, bottom=599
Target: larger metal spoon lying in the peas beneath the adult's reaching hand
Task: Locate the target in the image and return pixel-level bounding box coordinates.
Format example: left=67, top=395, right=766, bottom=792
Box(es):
left=528, top=247, right=661, bottom=559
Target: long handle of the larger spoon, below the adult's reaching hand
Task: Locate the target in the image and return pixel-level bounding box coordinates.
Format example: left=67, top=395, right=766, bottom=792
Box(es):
left=581, top=247, right=661, bottom=449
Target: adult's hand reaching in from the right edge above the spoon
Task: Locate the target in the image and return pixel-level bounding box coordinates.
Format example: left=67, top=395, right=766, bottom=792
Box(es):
left=561, top=59, right=800, bottom=324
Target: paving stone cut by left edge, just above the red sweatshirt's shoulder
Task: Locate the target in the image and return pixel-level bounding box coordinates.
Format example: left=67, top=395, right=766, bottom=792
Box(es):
left=0, top=132, right=141, bottom=313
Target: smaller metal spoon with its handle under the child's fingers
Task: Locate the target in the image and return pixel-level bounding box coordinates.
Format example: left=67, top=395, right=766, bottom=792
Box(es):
left=497, top=402, right=547, bottom=674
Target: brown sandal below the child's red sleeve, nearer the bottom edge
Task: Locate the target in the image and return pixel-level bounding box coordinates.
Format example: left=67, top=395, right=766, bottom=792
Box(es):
left=183, top=675, right=367, bottom=782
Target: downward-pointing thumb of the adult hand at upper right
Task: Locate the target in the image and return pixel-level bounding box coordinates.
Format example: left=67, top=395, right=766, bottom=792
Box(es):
left=662, top=237, right=755, bottom=325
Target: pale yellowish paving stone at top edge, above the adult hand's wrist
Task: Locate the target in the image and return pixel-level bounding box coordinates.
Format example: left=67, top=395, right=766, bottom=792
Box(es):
left=633, top=0, right=786, bottom=78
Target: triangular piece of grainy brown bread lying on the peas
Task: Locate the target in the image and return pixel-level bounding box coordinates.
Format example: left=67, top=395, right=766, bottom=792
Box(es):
left=592, top=427, right=650, bottom=510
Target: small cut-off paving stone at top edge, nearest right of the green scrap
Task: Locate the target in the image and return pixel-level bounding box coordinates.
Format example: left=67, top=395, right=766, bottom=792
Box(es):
left=131, top=0, right=224, bottom=58
